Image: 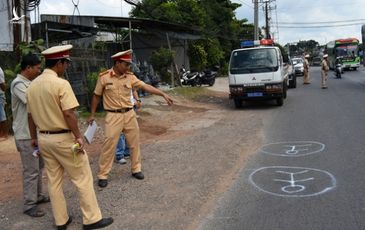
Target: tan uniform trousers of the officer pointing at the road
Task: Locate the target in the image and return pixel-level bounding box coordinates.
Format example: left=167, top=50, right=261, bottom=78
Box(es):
left=98, top=110, right=141, bottom=179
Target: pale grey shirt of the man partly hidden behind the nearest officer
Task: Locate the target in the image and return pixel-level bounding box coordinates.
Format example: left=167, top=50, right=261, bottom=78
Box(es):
left=10, top=74, right=31, bottom=140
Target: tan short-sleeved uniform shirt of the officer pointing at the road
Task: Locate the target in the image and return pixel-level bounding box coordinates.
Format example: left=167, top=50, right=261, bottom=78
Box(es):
left=94, top=69, right=145, bottom=110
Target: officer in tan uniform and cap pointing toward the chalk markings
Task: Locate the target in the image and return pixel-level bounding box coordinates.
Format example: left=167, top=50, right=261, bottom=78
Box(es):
left=88, top=50, right=173, bottom=187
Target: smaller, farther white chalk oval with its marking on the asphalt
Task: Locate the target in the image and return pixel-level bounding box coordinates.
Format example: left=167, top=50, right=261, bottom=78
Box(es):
left=259, top=141, right=325, bottom=157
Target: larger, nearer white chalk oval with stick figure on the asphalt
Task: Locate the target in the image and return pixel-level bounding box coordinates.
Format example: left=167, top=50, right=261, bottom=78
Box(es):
left=249, top=166, right=336, bottom=197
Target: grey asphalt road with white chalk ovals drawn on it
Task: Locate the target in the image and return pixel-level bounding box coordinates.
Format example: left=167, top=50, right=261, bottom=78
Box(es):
left=199, top=67, right=365, bottom=230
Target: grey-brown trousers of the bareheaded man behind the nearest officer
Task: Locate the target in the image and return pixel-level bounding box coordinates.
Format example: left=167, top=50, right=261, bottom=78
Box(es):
left=15, top=140, right=44, bottom=211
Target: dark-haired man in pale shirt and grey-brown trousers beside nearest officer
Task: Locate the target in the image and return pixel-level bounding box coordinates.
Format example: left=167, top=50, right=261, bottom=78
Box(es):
left=10, top=54, right=49, bottom=217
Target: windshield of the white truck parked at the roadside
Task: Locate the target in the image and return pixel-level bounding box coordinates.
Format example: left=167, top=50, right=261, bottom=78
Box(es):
left=230, top=49, right=279, bottom=74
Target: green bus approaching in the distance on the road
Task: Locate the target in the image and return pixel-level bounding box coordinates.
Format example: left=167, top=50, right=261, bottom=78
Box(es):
left=326, top=38, right=360, bottom=70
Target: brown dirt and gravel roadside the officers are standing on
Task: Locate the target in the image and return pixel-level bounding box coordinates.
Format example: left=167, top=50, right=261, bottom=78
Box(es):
left=0, top=78, right=262, bottom=229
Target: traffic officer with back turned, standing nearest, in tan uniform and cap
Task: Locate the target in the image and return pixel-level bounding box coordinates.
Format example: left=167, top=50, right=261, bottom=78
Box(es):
left=27, top=45, right=113, bottom=229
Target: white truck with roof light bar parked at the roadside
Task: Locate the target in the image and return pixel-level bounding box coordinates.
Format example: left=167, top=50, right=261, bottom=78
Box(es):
left=228, top=40, right=289, bottom=108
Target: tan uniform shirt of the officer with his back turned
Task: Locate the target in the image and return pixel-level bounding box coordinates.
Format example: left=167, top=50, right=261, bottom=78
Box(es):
left=27, top=69, right=79, bottom=131
